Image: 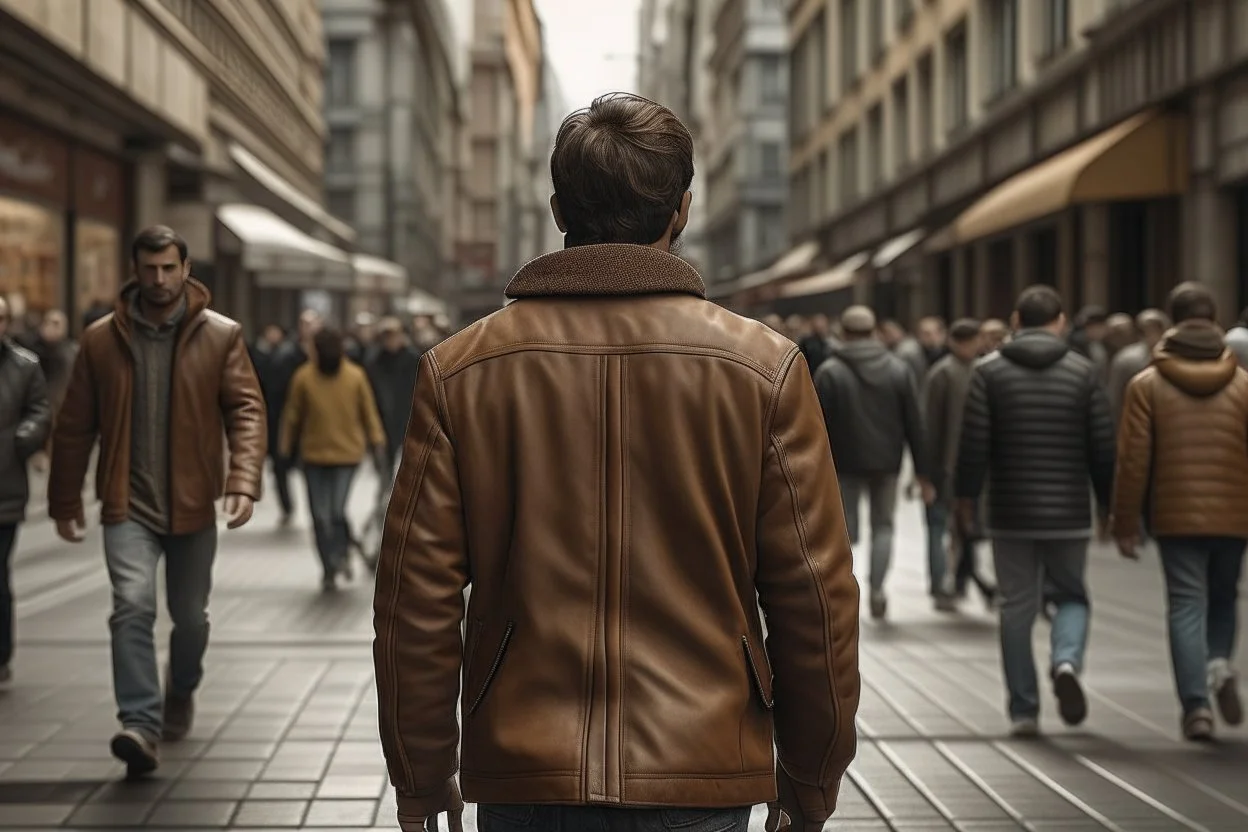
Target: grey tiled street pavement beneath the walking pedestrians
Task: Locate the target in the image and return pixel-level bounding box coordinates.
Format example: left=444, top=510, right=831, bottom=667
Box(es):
left=0, top=469, right=1248, bottom=832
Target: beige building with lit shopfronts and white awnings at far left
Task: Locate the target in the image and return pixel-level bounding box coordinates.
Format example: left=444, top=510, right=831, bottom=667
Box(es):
left=0, top=0, right=392, bottom=329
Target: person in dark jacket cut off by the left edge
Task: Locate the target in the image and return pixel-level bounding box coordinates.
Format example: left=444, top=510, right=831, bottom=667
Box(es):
left=0, top=297, right=51, bottom=685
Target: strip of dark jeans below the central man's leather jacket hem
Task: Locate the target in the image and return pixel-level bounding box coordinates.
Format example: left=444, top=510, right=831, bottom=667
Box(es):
left=477, top=803, right=750, bottom=832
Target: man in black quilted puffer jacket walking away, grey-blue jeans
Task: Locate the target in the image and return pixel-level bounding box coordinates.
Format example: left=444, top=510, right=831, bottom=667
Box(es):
left=955, top=286, right=1114, bottom=736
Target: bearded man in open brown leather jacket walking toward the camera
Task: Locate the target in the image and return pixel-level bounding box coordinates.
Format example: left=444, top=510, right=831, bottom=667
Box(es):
left=47, top=226, right=267, bottom=776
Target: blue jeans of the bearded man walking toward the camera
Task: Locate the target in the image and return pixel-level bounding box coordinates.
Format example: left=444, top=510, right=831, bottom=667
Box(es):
left=104, top=520, right=217, bottom=740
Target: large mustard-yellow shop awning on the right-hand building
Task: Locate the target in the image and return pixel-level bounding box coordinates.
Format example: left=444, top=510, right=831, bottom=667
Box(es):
left=953, top=111, right=1187, bottom=243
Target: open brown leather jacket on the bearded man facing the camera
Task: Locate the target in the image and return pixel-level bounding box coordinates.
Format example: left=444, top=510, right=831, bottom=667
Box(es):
left=47, top=279, right=268, bottom=534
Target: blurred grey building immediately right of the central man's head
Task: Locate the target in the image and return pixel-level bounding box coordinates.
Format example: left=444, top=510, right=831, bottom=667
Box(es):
left=701, top=0, right=789, bottom=296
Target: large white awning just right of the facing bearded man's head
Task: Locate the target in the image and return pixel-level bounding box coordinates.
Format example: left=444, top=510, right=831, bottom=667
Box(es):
left=217, top=203, right=354, bottom=292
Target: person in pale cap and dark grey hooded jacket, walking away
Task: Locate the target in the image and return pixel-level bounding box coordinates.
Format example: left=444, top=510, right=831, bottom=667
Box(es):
left=815, top=306, right=936, bottom=619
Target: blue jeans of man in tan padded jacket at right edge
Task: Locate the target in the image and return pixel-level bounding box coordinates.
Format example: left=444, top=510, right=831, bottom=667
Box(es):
left=1157, top=538, right=1244, bottom=713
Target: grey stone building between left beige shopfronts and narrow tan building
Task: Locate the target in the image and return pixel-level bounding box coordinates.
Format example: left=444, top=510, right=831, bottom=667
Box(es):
left=321, top=0, right=463, bottom=313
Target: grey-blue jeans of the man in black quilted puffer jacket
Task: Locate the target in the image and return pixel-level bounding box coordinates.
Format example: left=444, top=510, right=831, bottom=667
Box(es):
left=992, top=538, right=1091, bottom=720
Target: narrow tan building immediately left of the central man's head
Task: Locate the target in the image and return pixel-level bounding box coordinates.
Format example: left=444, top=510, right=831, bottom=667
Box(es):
left=454, top=0, right=543, bottom=321
